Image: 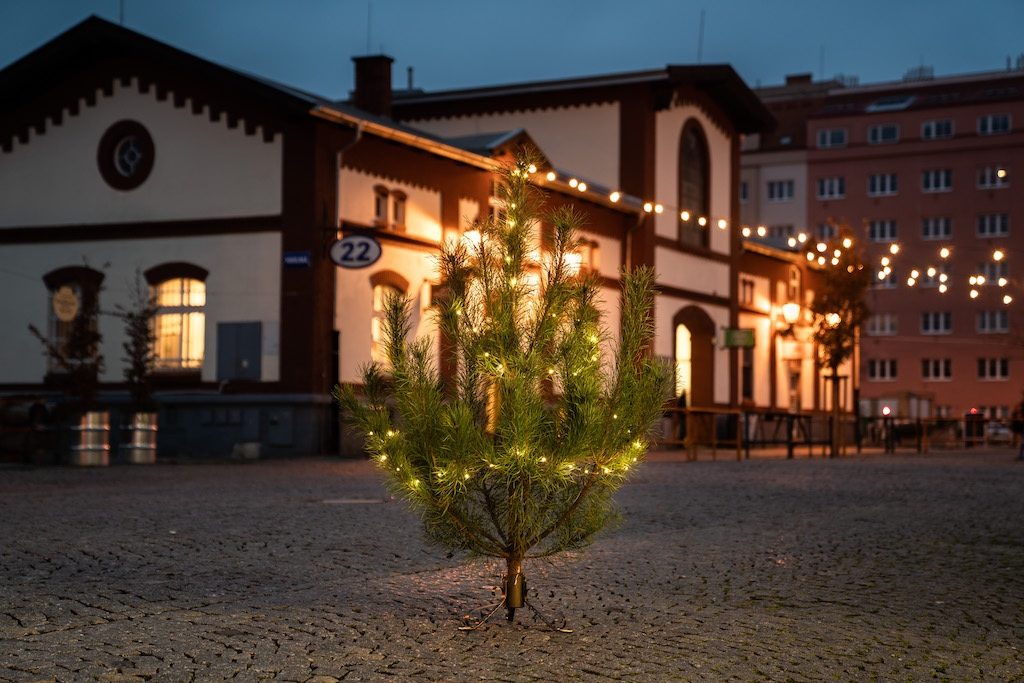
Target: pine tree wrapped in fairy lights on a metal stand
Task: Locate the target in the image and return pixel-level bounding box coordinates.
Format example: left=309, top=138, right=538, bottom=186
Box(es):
left=336, top=158, right=670, bottom=621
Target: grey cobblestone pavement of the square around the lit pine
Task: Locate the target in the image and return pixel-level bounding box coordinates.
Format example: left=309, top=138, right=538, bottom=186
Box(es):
left=0, top=451, right=1024, bottom=683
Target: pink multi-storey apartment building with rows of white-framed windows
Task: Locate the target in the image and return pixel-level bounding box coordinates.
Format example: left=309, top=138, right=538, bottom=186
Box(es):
left=806, top=69, right=1024, bottom=418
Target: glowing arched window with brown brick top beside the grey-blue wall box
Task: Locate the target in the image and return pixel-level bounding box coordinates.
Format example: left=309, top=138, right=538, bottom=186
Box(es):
left=145, top=263, right=208, bottom=372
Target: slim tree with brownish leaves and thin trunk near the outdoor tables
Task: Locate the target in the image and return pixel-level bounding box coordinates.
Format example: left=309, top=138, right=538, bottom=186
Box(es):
left=811, top=228, right=871, bottom=458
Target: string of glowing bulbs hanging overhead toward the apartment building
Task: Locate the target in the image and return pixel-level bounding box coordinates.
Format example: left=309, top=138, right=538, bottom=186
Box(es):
left=528, top=165, right=1014, bottom=305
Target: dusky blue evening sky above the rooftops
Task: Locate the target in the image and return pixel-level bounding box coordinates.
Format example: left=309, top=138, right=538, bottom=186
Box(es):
left=0, top=0, right=1024, bottom=97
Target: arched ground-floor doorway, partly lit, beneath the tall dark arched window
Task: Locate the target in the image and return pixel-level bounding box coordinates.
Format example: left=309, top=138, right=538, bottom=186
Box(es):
left=672, top=306, right=715, bottom=405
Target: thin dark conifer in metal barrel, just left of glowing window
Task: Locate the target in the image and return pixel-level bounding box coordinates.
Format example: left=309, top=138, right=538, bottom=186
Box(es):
left=116, top=270, right=160, bottom=412
